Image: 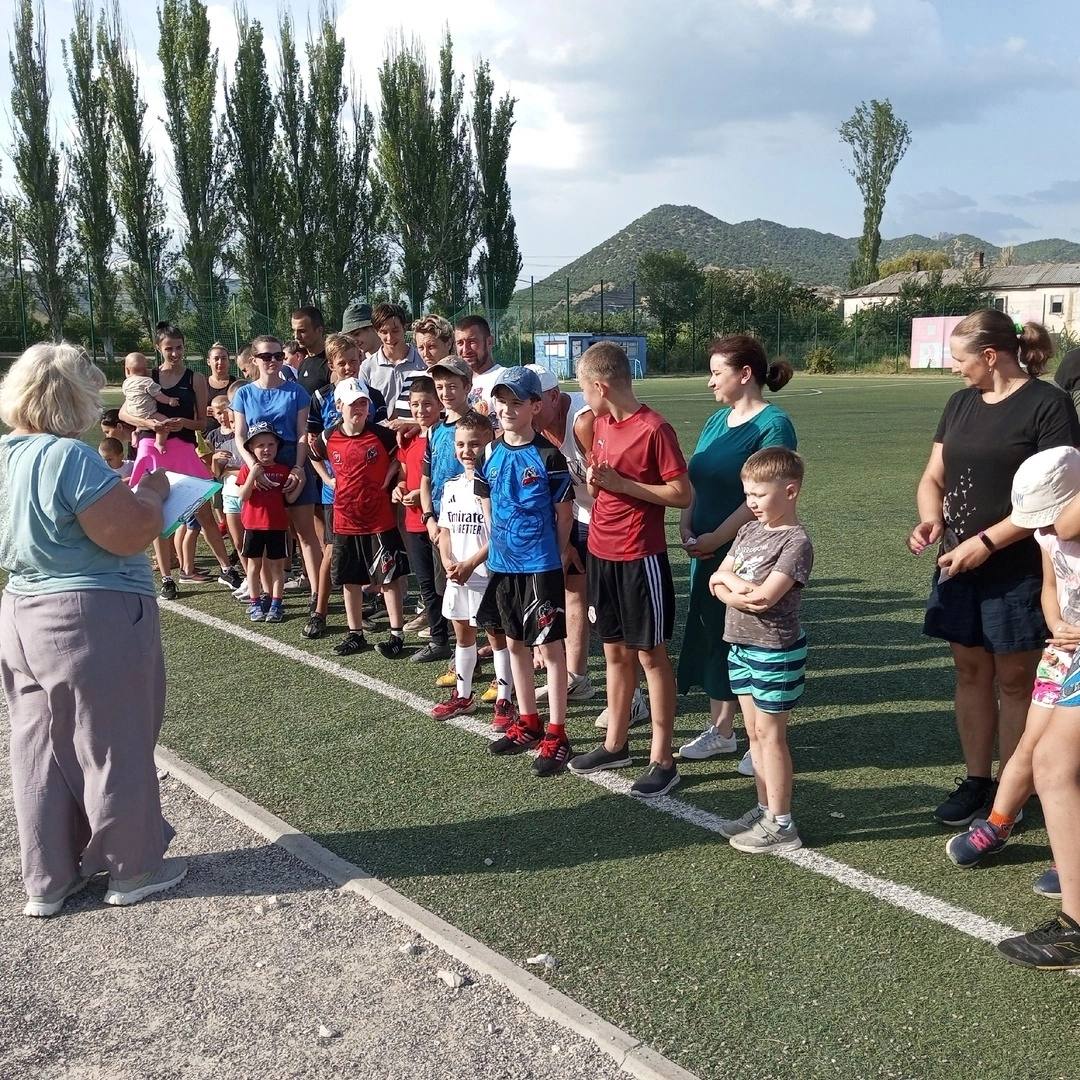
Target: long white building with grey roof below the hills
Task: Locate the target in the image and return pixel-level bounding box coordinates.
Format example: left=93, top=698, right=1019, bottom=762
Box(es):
left=843, top=262, right=1080, bottom=334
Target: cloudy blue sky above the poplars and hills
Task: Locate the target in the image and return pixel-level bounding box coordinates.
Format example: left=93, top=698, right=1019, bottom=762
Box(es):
left=0, top=0, right=1080, bottom=282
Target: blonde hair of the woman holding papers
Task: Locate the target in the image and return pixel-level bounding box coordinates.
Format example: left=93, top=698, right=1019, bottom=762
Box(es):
left=0, top=341, right=105, bottom=438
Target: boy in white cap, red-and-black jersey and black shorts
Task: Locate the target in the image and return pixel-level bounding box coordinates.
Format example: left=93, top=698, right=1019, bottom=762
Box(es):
left=326, top=379, right=408, bottom=660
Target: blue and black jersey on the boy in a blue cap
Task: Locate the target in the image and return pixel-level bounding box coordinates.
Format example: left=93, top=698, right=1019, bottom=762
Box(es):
left=476, top=434, right=573, bottom=573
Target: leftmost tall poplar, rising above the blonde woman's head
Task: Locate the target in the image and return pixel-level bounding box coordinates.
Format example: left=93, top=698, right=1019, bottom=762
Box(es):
left=8, top=0, right=73, bottom=341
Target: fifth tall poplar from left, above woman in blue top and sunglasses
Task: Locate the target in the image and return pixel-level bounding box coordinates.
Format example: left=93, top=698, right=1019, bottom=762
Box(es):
left=222, top=4, right=282, bottom=335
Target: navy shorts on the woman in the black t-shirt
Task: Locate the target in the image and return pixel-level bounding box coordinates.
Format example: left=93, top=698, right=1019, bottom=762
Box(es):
left=922, top=569, right=1050, bottom=653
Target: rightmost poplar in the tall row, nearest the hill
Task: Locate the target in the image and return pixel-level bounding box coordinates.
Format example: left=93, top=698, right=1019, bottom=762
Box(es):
left=472, top=60, right=522, bottom=312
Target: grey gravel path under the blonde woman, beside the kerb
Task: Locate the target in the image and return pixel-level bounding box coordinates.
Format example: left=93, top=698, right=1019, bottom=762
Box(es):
left=0, top=743, right=626, bottom=1080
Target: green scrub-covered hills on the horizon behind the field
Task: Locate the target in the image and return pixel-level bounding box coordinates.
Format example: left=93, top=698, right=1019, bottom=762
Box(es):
left=518, top=204, right=1080, bottom=298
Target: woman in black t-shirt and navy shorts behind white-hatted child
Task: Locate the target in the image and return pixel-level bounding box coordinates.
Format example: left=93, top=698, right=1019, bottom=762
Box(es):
left=907, top=310, right=1080, bottom=825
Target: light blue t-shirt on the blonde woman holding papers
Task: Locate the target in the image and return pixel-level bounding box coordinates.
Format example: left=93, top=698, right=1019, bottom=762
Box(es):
left=0, top=435, right=154, bottom=596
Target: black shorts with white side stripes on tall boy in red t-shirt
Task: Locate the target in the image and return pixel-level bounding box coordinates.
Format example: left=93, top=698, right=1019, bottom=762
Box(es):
left=589, top=552, right=675, bottom=651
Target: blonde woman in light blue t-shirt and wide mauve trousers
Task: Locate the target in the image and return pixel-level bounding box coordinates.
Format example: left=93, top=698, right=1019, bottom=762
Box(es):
left=0, top=345, right=187, bottom=916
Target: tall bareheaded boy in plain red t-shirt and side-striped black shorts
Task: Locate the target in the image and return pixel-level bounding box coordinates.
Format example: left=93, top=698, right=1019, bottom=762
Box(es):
left=569, top=341, right=690, bottom=798
